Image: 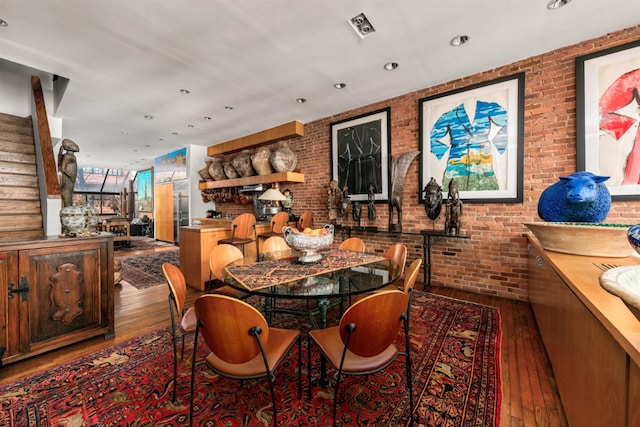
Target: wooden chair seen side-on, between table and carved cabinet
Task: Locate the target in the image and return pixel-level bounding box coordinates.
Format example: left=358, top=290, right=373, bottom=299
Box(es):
left=162, top=263, right=196, bottom=401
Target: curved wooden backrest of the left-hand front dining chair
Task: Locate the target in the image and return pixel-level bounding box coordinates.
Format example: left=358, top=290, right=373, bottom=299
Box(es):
left=195, top=294, right=269, bottom=364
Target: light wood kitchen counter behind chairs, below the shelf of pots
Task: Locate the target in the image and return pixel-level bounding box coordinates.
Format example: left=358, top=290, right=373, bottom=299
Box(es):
left=179, top=219, right=271, bottom=291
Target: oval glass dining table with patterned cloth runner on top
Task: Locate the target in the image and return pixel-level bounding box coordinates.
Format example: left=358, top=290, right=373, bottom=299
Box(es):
left=222, top=250, right=400, bottom=328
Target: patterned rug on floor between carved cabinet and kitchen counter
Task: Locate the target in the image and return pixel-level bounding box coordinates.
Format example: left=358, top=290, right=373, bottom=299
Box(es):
left=118, top=248, right=180, bottom=289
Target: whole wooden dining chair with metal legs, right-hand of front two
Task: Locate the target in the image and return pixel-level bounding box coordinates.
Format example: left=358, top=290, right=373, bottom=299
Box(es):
left=307, top=290, right=413, bottom=426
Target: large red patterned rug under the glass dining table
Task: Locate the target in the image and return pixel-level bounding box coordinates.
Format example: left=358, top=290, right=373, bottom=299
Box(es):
left=0, top=292, right=501, bottom=427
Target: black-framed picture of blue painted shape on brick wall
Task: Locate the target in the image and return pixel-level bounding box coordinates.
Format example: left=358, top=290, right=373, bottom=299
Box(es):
left=418, top=73, right=524, bottom=203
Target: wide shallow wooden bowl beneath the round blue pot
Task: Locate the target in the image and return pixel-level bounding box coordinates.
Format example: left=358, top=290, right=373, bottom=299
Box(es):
left=525, top=222, right=634, bottom=258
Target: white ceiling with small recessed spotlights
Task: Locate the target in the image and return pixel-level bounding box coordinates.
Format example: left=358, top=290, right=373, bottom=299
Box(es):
left=0, top=0, right=640, bottom=170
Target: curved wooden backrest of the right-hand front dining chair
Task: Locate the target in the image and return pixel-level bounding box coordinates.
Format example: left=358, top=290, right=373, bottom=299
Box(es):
left=340, top=290, right=407, bottom=357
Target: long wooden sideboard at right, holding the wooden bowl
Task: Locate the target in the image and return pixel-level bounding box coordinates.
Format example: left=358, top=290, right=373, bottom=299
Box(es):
left=529, top=235, right=640, bottom=427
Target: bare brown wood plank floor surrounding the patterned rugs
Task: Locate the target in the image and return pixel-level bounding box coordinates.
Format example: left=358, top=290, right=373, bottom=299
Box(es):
left=0, top=250, right=567, bottom=427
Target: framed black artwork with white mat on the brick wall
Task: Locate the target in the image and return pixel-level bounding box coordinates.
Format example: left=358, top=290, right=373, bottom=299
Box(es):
left=329, top=107, right=391, bottom=203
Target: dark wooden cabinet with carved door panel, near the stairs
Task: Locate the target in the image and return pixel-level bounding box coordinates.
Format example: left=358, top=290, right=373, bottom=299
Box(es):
left=0, top=235, right=114, bottom=364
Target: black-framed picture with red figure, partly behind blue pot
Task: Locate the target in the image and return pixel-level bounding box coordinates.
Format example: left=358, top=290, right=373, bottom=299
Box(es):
left=576, top=40, right=640, bottom=201
